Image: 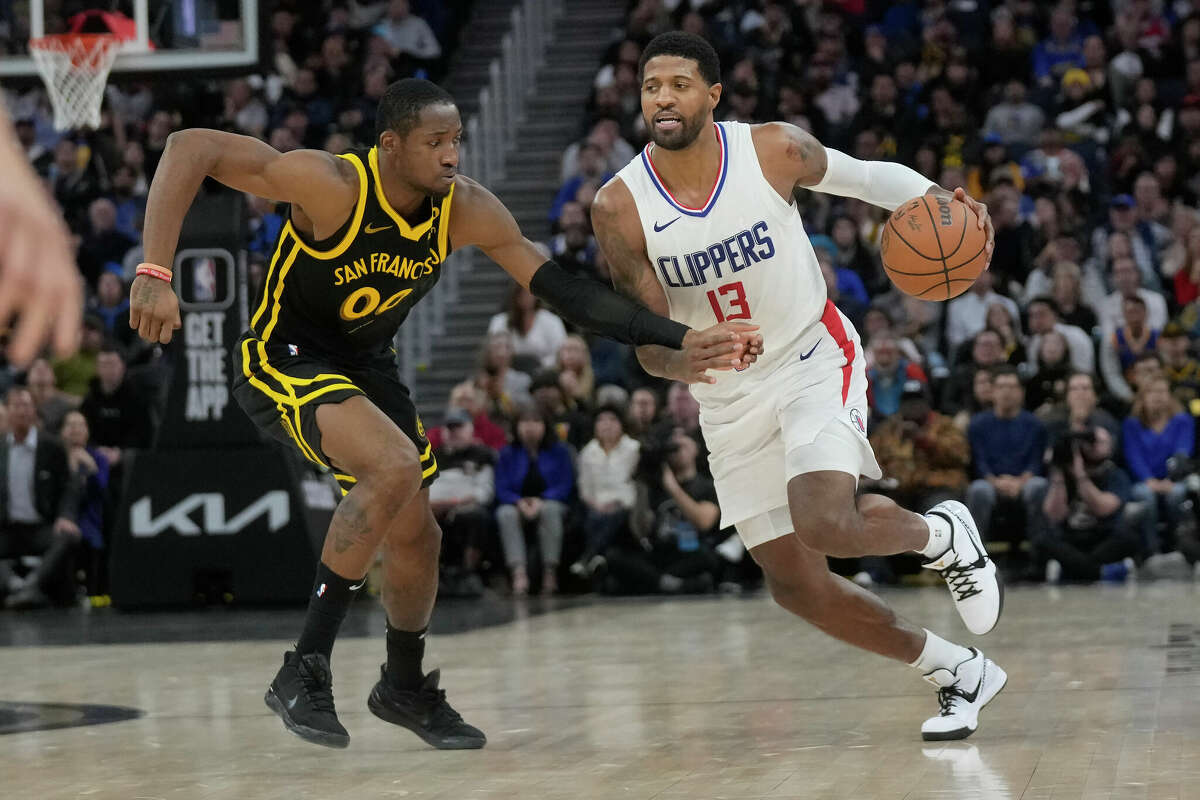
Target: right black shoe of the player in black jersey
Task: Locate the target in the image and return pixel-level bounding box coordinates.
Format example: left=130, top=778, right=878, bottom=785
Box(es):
left=367, top=667, right=487, bottom=750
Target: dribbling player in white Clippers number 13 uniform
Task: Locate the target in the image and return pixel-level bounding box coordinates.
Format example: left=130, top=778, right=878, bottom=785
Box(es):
left=593, top=32, right=1007, bottom=740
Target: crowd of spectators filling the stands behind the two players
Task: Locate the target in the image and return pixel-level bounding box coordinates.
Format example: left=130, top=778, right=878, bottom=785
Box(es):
left=7, top=0, right=1200, bottom=609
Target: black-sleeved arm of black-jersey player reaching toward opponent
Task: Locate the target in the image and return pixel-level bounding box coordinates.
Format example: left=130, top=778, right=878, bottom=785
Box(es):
left=450, top=176, right=749, bottom=380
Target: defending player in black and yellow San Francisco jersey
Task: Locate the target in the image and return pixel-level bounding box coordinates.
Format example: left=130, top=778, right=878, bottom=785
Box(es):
left=130, top=79, right=762, bottom=748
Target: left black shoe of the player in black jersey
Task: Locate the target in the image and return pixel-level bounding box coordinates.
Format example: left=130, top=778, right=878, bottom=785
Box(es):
left=263, top=650, right=350, bottom=747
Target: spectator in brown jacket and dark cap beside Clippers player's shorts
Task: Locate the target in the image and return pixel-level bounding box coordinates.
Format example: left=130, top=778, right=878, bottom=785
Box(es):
left=871, top=380, right=971, bottom=510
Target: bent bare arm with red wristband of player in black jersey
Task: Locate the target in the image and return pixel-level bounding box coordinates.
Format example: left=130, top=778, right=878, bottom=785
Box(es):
left=130, top=128, right=359, bottom=344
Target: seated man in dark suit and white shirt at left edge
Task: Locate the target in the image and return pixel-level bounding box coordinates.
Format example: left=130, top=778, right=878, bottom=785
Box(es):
left=0, top=386, right=79, bottom=609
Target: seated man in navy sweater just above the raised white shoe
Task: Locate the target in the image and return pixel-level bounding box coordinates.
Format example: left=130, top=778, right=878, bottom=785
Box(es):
left=967, top=365, right=1046, bottom=551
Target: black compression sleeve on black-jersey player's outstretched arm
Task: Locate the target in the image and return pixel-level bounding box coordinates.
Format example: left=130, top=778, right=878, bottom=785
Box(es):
left=529, top=261, right=691, bottom=350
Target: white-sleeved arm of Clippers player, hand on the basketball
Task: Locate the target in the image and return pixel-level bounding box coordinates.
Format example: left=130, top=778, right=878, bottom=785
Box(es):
left=754, top=122, right=996, bottom=261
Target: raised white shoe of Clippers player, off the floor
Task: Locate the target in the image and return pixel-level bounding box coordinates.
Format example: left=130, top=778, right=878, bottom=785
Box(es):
left=922, top=500, right=1004, bottom=636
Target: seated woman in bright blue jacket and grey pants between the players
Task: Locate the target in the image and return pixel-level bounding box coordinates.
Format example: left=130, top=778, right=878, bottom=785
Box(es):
left=496, top=404, right=575, bottom=596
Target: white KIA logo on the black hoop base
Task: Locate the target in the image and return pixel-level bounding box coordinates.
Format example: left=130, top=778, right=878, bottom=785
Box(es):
left=130, top=489, right=292, bottom=539
